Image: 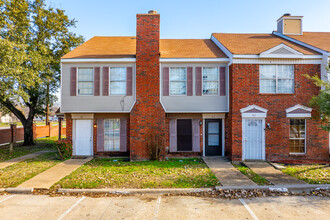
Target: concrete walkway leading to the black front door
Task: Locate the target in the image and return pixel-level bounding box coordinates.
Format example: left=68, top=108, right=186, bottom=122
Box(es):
left=203, top=157, right=257, bottom=186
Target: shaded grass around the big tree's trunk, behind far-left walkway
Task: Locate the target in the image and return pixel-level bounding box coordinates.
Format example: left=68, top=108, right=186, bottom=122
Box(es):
left=0, top=137, right=57, bottom=162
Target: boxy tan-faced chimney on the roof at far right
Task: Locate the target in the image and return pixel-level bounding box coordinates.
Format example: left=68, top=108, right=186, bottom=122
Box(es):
left=277, top=13, right=303, bottom=35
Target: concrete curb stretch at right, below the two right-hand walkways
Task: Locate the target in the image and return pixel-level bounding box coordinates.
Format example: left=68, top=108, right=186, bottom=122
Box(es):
left=215, top=184, right=330, bottom=193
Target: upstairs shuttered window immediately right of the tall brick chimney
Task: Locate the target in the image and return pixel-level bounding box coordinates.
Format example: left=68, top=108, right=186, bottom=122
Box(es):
left=170, top=67, right=187, bottom=95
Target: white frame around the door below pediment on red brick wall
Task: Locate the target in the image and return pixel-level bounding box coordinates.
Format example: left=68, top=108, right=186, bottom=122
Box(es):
left=242, top=117, right=266, bottom=160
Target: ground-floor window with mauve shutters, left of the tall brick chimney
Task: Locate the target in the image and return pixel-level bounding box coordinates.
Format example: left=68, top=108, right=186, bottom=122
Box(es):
left=104, top=119, right=120, bottom=151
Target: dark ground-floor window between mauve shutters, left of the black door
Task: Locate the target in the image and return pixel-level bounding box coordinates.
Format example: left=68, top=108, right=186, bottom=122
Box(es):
left=177, top=119, right=192, bottom=151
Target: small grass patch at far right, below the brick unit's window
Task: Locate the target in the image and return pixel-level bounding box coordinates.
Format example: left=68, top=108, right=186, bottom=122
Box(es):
left=282, top=164, right=330, bottom=184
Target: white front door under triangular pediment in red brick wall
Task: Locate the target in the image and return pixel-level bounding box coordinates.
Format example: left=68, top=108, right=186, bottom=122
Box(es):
left=243, top=118, right=265, bottom=160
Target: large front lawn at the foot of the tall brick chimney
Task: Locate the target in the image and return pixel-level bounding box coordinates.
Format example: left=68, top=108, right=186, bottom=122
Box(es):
left=54, top=158, right=220, bottom=188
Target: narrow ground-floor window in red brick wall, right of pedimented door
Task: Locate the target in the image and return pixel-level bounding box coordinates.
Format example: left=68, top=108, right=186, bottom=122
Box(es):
left=290, top=119, right=306, bottom=153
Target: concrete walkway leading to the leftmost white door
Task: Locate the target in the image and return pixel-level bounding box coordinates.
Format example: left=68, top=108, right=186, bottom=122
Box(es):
left=18, top=157, right=92, bottom=189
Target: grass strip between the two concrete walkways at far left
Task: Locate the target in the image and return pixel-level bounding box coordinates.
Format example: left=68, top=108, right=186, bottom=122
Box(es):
left=0, top=152, right=62, bottom=188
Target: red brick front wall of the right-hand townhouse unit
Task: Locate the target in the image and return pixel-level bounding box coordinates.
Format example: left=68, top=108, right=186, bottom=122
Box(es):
left=226, top=64, right=329, bottom=161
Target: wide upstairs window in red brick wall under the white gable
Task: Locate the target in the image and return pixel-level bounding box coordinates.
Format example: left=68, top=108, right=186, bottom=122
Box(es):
left=259, top=65, right=294, bottom=93
